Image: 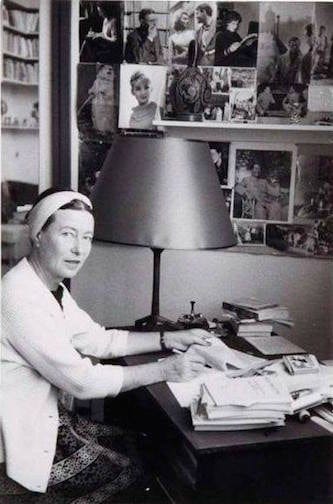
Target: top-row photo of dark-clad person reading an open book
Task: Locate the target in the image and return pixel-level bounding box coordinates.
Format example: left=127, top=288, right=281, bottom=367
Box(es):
left=215, top=2, right=259, bottom=67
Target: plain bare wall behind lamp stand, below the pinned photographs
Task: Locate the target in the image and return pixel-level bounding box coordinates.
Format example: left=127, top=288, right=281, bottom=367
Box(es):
left=72, top=242, right=333, bottom=358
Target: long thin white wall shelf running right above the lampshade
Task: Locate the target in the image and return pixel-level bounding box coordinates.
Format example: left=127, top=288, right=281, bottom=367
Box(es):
left=153, top=120, right=333, bottom=132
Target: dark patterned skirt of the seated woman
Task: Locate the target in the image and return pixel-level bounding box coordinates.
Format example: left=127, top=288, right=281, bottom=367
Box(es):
left=0, top=402, right=147, bottom=504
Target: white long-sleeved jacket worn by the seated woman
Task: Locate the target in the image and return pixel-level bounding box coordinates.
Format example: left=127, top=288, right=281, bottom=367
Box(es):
left=0, top=259, right=128, bottom=492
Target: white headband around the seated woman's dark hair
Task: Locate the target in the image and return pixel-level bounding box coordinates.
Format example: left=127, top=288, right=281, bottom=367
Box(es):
left=28, top=191, right=92, bottom=239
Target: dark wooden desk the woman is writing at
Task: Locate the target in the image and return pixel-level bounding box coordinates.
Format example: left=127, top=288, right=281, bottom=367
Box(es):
left=111, top=354, right=333, bottom=504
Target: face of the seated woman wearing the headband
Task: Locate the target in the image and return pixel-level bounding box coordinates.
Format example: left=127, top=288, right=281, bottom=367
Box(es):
left=34, top=209, right=94, bottom=284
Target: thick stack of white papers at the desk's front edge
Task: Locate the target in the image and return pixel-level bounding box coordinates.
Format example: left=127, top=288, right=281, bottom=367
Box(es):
left=191, top=375, right=292, bottom=431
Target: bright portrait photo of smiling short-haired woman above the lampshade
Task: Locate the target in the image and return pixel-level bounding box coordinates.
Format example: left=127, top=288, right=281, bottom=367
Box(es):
left=119, top=64, right=167, bottom=130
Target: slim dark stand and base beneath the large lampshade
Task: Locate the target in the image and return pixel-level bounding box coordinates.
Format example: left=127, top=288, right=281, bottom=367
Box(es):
left=135, top=248, right=183, bottom=331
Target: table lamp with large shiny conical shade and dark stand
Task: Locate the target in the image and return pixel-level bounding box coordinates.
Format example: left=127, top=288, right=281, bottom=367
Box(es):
left=91, top=136, right=236, bottom=331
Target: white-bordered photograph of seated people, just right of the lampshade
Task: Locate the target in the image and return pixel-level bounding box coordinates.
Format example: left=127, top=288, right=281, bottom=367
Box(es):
left=229, top=143, right=296, bottom=222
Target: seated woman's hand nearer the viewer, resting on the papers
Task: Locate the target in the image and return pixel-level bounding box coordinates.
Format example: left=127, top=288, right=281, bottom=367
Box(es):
left=160, top=349, right=205, bottom=382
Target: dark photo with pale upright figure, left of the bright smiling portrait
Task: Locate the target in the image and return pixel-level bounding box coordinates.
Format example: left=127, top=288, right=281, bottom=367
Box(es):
left=76, top=63, right=119, bottom=142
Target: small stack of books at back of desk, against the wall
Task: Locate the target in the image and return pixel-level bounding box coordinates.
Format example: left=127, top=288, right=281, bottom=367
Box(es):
left=222, top=298, right=292, bottom=325
